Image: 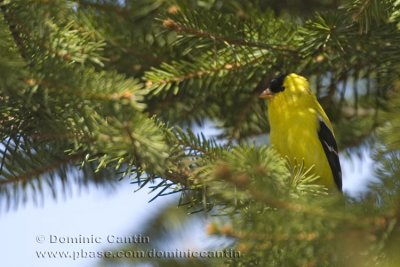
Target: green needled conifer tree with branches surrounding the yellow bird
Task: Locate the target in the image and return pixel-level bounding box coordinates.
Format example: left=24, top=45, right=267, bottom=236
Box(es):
left=0, top=0, right=400, bottom=267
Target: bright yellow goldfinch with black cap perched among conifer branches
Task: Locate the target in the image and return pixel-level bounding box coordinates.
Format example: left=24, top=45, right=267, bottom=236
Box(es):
left=260, top=73, right=342, bottom=191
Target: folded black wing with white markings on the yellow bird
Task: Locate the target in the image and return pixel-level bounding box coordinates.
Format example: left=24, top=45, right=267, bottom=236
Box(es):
left=318, top=118, right=342, bottom=191
